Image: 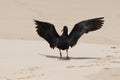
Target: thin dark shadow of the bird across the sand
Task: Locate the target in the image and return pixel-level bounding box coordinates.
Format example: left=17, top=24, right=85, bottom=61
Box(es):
left=39, top=53, right=101, bottom=60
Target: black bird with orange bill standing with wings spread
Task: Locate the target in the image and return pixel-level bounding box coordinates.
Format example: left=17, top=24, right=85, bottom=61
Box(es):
left=34, top=17, right=104, bottom=59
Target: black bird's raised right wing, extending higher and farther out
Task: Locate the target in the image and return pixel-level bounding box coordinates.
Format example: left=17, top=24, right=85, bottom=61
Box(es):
left=69, top=17, right=104, bottom=47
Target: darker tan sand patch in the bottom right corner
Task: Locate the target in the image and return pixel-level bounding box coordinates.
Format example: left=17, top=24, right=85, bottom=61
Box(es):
left=89, top=68, right=120, bottom=80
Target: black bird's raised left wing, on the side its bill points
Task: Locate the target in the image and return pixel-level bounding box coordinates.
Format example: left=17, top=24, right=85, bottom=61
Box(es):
left=34, top=20, right=59, bottom=48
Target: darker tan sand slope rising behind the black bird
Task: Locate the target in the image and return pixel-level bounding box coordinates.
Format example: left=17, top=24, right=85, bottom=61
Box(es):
left=0, top=0, right=120, bottom=44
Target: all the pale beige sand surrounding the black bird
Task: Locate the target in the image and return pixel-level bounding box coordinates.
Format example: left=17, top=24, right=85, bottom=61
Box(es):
left=0, top=0, right=120, bottom=80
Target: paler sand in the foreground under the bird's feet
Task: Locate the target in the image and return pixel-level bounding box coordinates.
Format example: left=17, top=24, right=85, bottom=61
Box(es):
left=0, top=39, right=120, bottom=80
